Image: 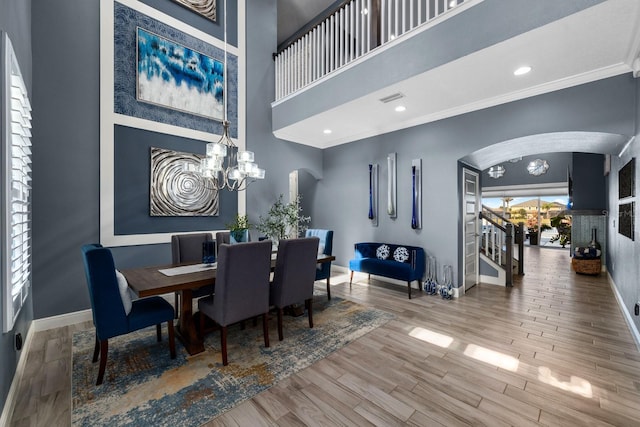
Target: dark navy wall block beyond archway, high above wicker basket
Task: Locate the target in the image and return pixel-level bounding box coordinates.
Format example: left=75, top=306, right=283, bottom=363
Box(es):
left=571, top=153, right=617, bottom=210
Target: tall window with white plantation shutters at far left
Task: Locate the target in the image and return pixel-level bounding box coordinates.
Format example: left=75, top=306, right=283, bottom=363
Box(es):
left=0, top=33, right=31, bottom=332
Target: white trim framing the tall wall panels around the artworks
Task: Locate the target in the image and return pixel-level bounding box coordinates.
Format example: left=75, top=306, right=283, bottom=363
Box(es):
left=100, top=0, right=246, bottom=246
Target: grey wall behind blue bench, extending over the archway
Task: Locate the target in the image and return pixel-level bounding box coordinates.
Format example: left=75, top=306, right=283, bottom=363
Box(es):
left=320, top=74, right=635, bottom=284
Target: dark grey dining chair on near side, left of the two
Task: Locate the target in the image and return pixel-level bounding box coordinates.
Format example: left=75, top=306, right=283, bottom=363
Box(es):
left=198, top=240, right=271, bottom=366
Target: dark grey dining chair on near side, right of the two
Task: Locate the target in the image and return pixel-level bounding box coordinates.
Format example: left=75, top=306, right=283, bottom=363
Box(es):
left=269, top=237, right=320, bottom=341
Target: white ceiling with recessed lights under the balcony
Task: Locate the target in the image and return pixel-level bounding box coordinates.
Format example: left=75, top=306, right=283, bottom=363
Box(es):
left=274, top=0, right=640, bottom=158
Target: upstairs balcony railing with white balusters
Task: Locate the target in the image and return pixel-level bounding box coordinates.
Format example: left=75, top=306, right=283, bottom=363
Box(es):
left=275, top=0, right=469, bottom=101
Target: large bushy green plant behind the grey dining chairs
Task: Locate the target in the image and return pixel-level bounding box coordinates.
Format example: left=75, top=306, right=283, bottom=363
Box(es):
left=256, top=194, right=311, bottom=241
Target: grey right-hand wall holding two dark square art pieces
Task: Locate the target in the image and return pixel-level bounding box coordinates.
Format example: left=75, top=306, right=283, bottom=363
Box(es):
left=607, top=79, right=640, bottom=339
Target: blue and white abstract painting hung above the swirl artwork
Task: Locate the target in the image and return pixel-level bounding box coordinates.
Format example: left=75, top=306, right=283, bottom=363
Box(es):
left=137, top=27, right=224, bottom=120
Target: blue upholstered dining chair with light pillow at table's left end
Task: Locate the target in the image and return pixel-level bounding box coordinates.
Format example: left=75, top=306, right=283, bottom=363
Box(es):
left=82, top=244, right=176, bottom=385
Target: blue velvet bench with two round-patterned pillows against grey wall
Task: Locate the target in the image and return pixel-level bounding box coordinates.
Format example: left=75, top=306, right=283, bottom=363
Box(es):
left=349, top=242, right=425, bottom=299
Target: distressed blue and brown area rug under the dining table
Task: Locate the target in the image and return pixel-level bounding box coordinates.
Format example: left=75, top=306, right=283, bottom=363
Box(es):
left=72, top=295, right=393, bottom=426
